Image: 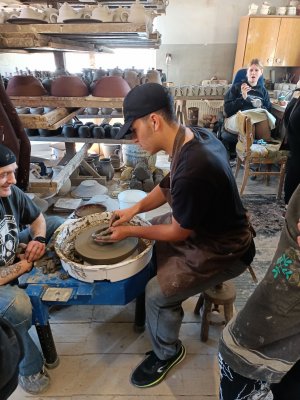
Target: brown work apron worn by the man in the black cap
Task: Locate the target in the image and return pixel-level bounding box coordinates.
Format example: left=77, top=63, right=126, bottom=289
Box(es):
left=151, top=126, right=252, bottom=296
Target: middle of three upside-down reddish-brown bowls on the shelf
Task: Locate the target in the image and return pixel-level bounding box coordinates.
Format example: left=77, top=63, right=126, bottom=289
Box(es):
left=51, top=76, right=89, bottom=97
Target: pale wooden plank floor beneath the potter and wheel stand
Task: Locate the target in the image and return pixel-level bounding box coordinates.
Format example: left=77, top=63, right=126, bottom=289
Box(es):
left=10, top=146, right=279, bottom=400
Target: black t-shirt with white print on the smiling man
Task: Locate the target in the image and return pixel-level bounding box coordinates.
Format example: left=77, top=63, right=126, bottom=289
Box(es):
left=0, top=186, right=41, bottom=266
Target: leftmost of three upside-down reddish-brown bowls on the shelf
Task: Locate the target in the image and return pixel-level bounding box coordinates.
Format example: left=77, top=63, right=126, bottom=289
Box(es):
left=6, top=75, right=48, bottom=96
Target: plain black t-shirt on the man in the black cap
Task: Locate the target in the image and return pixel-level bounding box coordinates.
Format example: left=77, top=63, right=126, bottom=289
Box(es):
left=171, top=129, right=248, bottom=236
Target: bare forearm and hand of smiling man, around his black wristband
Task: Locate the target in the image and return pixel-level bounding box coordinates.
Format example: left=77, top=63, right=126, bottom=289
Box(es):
left=25, top=214, right=46, bottom=262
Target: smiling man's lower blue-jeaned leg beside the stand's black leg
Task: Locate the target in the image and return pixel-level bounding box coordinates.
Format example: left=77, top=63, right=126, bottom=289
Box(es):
left=0, top=285, right=44, bottom=375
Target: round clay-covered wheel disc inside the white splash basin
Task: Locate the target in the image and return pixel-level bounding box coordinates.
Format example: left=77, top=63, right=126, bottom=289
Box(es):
left=75, top=224, right=138, bottom=265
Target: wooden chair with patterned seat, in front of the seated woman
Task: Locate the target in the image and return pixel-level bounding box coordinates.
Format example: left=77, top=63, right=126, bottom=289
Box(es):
left=235, top=111, right=288, bottom=199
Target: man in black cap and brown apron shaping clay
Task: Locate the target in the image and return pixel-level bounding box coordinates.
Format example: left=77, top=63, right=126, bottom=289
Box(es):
left=94, top=83, right=255, bottom=388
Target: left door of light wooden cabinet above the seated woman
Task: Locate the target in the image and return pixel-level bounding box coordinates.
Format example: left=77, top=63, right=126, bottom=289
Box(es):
left=244, top=17, right=281, bottom=66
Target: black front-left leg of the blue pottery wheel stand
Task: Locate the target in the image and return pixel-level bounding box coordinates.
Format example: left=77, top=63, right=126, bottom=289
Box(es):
left=35, top=322, right=59, bottom=368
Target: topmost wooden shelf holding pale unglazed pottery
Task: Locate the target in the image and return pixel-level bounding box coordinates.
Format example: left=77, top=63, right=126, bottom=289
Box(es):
left=0, top=0, right=166, bottom=52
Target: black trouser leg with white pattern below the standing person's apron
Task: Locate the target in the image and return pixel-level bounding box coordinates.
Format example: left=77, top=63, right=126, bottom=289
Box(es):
left=219, top=354, right=270, bottom=400
